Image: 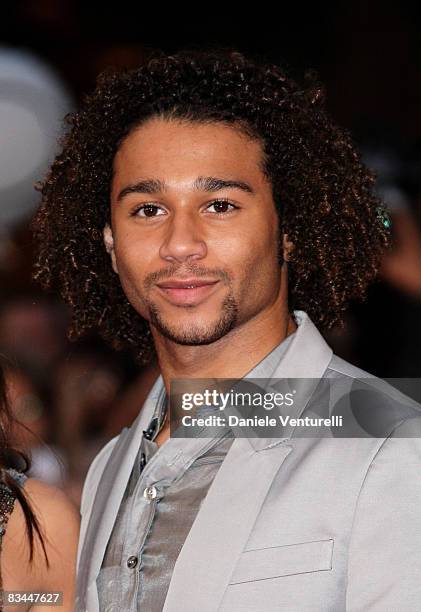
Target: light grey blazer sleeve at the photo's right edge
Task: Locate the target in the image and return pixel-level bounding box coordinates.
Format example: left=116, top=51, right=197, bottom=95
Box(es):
left=346, top=417, right=421, bottom=612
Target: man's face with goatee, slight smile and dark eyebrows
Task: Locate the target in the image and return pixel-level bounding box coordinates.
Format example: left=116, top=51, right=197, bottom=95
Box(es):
left=104, top=118, right=280, bottom=345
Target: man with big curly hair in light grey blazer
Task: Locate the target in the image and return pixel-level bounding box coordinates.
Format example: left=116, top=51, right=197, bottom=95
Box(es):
left=32, top=52, right=421, bottom=612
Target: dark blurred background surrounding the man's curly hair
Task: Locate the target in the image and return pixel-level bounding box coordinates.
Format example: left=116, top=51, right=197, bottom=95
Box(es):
left=0, top=0, right=421, bottom=503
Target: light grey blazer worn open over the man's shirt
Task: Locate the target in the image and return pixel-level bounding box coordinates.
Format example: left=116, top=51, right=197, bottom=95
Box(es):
left=77, top=311, right=421, bottom=612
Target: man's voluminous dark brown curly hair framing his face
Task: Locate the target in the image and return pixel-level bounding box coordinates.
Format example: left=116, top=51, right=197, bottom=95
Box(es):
left=33, top=50, right=390, bottom=363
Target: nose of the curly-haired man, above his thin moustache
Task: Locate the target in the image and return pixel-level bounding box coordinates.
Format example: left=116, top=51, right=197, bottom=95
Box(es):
left=159, top=212, right=207, bottom=263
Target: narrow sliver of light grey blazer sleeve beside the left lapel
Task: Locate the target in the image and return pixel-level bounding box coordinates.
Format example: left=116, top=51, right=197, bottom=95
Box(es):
left=77, top=430, right=120, bottom=568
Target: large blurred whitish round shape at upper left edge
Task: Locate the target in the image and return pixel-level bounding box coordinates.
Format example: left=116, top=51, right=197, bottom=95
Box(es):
left=0, top=47, right=73, bottom=231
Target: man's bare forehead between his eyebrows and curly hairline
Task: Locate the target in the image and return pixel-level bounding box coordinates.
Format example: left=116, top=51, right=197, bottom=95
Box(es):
left=113, top=121, right=263, bottom=193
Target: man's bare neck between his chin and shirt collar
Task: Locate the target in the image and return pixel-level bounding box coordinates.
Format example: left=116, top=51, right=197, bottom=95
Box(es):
left=155, top=304, right=297, bottom=392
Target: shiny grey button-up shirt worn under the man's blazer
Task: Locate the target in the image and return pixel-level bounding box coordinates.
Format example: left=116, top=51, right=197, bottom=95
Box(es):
left=97, top=334, right=294, bottom=612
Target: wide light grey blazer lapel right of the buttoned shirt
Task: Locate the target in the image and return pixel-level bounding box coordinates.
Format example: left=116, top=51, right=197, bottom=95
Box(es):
left=163, top=438, right=292, bottom=612
